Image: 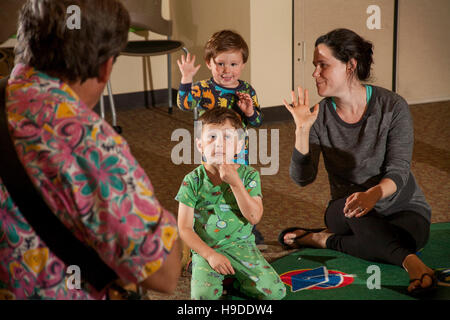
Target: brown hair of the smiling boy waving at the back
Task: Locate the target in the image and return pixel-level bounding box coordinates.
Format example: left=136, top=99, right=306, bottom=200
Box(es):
left=204, top=30, right=248, bottom=63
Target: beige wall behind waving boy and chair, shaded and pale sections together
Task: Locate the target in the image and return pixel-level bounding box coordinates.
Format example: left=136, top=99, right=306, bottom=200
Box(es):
left=111, top=0, right=292, bottom=107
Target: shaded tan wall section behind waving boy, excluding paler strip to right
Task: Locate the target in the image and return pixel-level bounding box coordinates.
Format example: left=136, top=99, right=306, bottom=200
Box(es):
left=111, top=0, right=251, bottom=93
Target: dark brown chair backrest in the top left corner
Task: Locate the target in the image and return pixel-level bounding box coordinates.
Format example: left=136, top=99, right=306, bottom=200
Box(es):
left=0, top=0, right=26, bottom=43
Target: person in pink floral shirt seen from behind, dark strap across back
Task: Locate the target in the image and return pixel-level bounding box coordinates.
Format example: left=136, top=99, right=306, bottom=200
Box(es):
left=0, top=0, right=181, bottom=299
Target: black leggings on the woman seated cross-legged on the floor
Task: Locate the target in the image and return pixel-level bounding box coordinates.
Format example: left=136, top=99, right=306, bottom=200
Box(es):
left=325, top=198, right=430, bottom=266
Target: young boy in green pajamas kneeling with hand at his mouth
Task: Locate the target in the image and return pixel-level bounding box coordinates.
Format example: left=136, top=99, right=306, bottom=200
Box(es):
left=175, top=108, right=286, bottom=300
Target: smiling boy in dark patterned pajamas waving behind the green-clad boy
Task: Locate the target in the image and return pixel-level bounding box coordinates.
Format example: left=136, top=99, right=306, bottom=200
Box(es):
left=177, top=30, right=264, bottom=244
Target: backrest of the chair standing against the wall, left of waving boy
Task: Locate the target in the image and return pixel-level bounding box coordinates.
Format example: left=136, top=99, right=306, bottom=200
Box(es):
left=121, top=0, right=172, bottom=36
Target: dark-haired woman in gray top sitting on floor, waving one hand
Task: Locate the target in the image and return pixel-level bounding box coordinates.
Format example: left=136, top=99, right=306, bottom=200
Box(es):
left=279, top=29, right=437, bottom=294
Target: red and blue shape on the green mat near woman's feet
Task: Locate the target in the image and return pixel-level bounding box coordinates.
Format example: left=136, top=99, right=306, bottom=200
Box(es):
left=280, top=266, right=355, bottom=292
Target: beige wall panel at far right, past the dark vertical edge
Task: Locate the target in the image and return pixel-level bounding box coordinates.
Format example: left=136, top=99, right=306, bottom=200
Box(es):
left=397, top=0, right=450, bottom=104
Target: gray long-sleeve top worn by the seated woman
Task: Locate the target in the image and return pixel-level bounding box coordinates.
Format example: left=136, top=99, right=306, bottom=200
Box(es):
left=289, top=86, right=431, bottom=221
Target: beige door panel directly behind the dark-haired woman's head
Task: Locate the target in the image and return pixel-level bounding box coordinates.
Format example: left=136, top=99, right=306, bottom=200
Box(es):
left=293, top=0, right=394, bottom=105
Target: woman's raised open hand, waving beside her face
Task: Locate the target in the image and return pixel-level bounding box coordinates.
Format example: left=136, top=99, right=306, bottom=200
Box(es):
left=283, top=87, right=319, bottom=130
